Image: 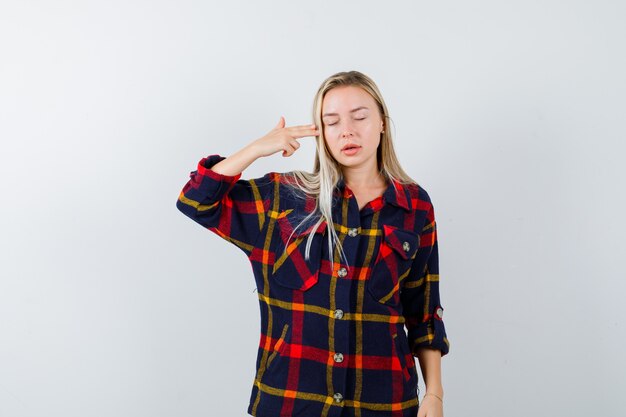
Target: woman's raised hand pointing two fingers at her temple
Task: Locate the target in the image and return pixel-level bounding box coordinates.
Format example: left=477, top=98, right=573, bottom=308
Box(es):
left=250, top=116, right=319, bottom=157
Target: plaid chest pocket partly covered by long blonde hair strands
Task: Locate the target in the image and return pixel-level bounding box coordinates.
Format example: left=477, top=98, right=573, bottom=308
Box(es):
left=272, top=213, right=326, bottom=291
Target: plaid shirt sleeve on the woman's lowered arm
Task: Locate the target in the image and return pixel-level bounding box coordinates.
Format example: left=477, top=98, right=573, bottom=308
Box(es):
left=400, top=200, right=450, bottom=356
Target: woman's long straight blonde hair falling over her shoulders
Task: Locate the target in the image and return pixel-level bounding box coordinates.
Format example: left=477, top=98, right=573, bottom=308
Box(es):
left=285, top=71, right=415, bottom=264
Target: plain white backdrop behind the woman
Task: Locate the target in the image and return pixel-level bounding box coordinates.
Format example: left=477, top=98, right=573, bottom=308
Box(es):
left=0, top=0, right=626, bottom=417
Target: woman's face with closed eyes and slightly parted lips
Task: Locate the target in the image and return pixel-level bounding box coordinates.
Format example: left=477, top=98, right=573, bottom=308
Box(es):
left=322, top=86, right=384, bottom=169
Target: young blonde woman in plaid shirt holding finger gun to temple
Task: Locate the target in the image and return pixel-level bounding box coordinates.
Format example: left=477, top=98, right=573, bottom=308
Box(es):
left=177, top=71, right=450, bottom=417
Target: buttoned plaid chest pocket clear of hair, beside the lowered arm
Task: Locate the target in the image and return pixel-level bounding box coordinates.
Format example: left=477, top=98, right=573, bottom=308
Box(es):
left=367, top=224, right=420, bottom=305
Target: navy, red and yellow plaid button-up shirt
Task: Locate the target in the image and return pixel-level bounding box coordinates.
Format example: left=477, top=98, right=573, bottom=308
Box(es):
left=176, top=154, right=450, bottom=417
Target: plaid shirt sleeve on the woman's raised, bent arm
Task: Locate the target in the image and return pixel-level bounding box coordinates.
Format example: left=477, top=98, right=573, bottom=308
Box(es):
left=176, top=154, right=276, bottom=257
